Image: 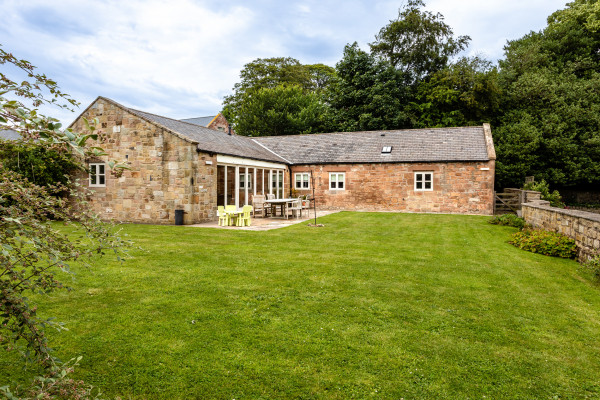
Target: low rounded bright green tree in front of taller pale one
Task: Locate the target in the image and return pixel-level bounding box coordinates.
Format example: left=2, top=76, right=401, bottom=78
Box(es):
left=236, top=85, right=327, bottom=136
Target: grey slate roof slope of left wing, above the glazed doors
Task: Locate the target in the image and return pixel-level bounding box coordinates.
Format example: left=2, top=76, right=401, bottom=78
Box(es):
left=121, top=106, right=287, bottom=164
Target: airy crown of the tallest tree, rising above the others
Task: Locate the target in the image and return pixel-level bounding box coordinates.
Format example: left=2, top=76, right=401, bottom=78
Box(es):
left=370, top=0, right=471, bottom=83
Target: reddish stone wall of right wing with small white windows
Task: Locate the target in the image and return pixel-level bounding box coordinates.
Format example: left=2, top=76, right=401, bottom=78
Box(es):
left=291, top=161, right=495, bottom=215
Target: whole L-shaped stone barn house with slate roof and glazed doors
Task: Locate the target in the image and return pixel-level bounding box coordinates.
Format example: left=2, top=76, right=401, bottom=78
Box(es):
left=71, top=97, right=496, bottom=224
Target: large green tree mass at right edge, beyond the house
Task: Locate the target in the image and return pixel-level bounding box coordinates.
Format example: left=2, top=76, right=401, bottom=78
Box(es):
left=494, top=0, right=600, bottom=186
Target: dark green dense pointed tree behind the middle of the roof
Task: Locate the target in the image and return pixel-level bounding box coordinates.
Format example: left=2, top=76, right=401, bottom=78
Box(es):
left=328, top=43, right=410, bottom=131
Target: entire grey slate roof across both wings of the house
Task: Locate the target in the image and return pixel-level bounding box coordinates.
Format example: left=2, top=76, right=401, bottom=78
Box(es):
left=77, top=97, right=495, bottom=165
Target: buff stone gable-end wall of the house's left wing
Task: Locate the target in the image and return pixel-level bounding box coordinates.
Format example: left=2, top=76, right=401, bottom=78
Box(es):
left=73, top=95, right=216, bottom=224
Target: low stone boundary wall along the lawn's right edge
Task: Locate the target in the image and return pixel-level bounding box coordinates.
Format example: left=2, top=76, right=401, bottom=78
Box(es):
left=522, top=201, right=600, bottom=260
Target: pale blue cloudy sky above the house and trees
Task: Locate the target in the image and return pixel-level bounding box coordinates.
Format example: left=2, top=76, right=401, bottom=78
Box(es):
left=0, top=0, right=565, bottom=124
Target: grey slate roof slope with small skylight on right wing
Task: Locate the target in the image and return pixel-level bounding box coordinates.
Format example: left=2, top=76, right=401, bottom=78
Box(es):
left=254, top=126, right=490, bottom=164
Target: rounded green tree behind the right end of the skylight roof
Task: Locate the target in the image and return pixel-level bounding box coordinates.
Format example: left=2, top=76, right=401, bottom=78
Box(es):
left=413, top=57, right=501, bottom=128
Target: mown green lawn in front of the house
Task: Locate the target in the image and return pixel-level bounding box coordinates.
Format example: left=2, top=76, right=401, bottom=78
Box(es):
left=0, top=212, right=600, bottom=399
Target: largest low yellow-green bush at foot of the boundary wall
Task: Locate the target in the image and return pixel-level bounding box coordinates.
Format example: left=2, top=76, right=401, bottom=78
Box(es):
left=509, top=229, right=577, bottom=258
